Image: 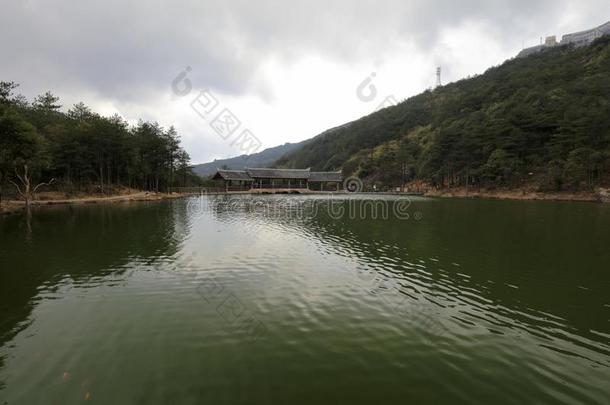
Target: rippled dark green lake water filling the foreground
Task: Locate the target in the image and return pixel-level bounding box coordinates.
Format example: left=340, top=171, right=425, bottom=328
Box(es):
left=0, top=196, right=610, bottom=404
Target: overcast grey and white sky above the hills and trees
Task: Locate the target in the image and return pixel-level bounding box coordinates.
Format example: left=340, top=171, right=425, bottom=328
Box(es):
left=0, top=0, right=610, bottom=163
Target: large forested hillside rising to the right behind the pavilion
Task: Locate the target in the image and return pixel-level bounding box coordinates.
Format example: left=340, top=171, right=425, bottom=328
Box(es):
left=277, top=37, right=610, bottom=191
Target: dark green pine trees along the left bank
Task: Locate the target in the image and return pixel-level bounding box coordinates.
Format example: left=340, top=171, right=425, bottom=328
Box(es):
left=0, top=82, right=199, bottom=202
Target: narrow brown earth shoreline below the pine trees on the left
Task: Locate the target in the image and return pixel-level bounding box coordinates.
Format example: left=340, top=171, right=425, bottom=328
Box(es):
left=0, top=191, right=190, bottom=216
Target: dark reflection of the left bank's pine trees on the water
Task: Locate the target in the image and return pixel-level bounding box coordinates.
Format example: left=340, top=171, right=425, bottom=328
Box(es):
left=0, top=205, right=187, bottom=384
